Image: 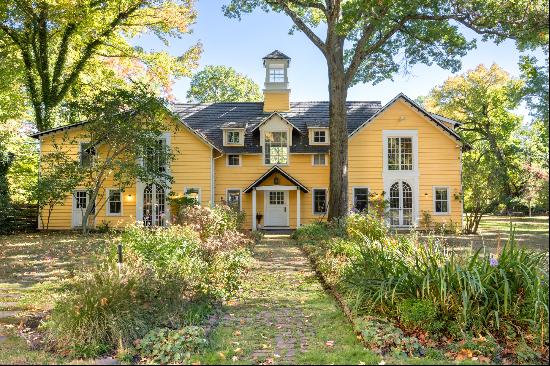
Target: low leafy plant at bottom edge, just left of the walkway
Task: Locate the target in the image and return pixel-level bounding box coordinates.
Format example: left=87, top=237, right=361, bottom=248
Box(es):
left=136, top=326, right=208, bottom=365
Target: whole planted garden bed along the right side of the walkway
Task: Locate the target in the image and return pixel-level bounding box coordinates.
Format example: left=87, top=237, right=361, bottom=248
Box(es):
left=294, top=215, right=548, bottom=363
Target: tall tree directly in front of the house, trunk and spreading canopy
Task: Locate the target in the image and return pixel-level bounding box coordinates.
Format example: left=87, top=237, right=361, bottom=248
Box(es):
left=224, top=0, right=548, bottom=219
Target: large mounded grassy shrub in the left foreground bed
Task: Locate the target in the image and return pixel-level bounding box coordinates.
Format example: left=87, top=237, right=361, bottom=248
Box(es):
left=46, top=258, right=194, bottom=357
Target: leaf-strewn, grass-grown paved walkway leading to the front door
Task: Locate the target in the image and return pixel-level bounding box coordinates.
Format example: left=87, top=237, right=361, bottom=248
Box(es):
left=200, top=235, right=376, bottom=364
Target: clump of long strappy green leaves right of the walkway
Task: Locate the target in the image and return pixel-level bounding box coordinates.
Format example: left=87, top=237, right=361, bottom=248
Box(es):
left=346, top=233, right=548, bottom=341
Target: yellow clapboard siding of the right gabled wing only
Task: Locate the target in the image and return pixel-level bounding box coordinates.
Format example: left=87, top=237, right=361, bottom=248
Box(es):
left=349, top=100, right=462, bottom=225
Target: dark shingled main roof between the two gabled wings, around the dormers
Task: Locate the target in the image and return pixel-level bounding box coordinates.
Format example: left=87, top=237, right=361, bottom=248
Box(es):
left=171, top=102, right=382, bottom=153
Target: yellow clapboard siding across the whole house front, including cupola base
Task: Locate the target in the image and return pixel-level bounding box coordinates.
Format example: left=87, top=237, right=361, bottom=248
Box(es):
left=36, top=93, right=462, bottom=229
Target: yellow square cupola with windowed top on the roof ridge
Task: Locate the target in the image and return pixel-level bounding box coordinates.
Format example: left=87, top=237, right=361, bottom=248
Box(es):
left=263, top=50, right=290, bottom=112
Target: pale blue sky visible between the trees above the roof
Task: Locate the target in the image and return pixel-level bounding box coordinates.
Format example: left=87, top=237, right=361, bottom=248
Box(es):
left=134, top=0, right=542, bottom=113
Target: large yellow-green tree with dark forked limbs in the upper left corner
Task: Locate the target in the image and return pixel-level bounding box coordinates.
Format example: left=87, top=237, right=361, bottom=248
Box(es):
left=0, top=0, right=200, bottom=131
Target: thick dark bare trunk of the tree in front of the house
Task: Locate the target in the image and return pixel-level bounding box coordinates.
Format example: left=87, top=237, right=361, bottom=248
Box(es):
left=328, top=51, right=348, bottom=221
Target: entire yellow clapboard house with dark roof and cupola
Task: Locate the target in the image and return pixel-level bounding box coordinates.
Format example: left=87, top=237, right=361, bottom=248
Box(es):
left=33, top=51, right=465, bottom=230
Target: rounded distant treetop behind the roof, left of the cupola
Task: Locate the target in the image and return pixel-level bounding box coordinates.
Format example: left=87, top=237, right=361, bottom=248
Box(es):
left=187, top=66, right=262, bottom=103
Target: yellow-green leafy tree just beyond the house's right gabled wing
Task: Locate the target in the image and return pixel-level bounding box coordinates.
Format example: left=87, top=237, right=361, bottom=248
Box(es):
left=424, top=65, right=527, bottom=232
